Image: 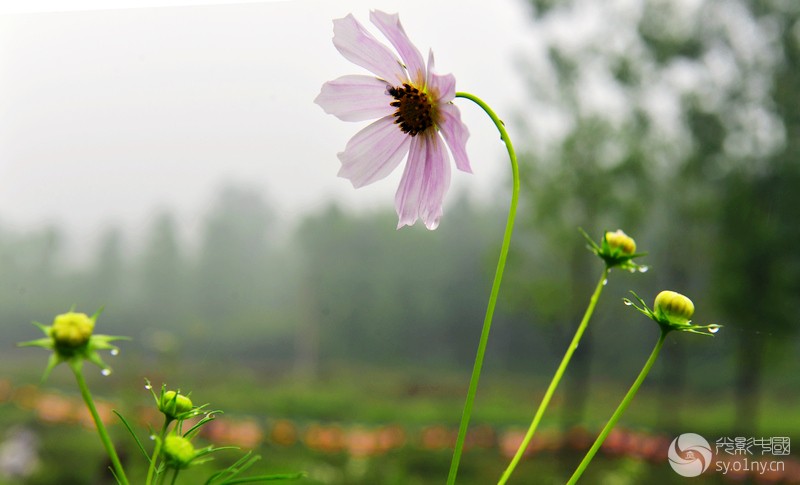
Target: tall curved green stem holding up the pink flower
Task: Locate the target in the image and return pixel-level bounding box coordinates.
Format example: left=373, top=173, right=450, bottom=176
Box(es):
left=447, top=92, right=519, bottom=485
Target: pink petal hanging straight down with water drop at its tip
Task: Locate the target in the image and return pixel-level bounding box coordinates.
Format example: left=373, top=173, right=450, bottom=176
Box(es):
left=395, top=130, right=450, bottom=230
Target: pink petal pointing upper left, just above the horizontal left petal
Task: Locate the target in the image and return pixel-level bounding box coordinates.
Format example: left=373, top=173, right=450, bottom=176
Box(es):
left=333, top=14, right=407, bottom=86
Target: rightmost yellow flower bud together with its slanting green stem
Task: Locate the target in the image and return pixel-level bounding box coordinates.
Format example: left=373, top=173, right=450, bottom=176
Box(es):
left=567, top=291, right=722, bottom=485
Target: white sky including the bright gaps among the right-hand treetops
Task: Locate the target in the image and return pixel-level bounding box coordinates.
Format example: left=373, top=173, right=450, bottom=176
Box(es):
left=0, top=0, right=764, bottom=255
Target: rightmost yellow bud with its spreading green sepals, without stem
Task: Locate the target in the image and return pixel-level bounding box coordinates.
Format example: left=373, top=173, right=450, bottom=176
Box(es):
left=622, top=290, right=722, bottom=336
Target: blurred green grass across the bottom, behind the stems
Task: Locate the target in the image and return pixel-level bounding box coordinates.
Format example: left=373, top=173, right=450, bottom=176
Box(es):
left=0, top=355, right=800, bottom=485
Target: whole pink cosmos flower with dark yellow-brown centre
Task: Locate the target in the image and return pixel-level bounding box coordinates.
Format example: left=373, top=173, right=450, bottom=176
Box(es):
left=314, top=10, right=472, bottom=229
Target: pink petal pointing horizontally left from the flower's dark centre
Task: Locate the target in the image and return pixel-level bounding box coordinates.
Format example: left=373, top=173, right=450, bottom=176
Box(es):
left=314, top=76, right=395, bottom=121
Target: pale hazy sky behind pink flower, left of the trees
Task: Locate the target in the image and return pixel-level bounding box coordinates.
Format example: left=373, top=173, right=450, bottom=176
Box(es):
left=0, top=0, right=531, bottom=250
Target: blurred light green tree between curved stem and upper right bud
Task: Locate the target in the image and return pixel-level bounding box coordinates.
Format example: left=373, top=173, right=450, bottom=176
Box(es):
left=510, top=2, right=665, bottom=427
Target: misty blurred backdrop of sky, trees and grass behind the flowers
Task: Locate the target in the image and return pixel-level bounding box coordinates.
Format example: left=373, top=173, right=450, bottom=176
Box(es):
left=0, top=0, right=800, bottom=483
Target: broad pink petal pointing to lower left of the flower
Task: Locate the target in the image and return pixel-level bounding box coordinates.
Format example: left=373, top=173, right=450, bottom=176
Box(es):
left=338, top=116, right=411, bottom=188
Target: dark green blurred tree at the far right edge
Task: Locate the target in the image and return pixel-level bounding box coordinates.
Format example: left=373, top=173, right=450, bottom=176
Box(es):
left=713, top=0, right=800, bottom=430
